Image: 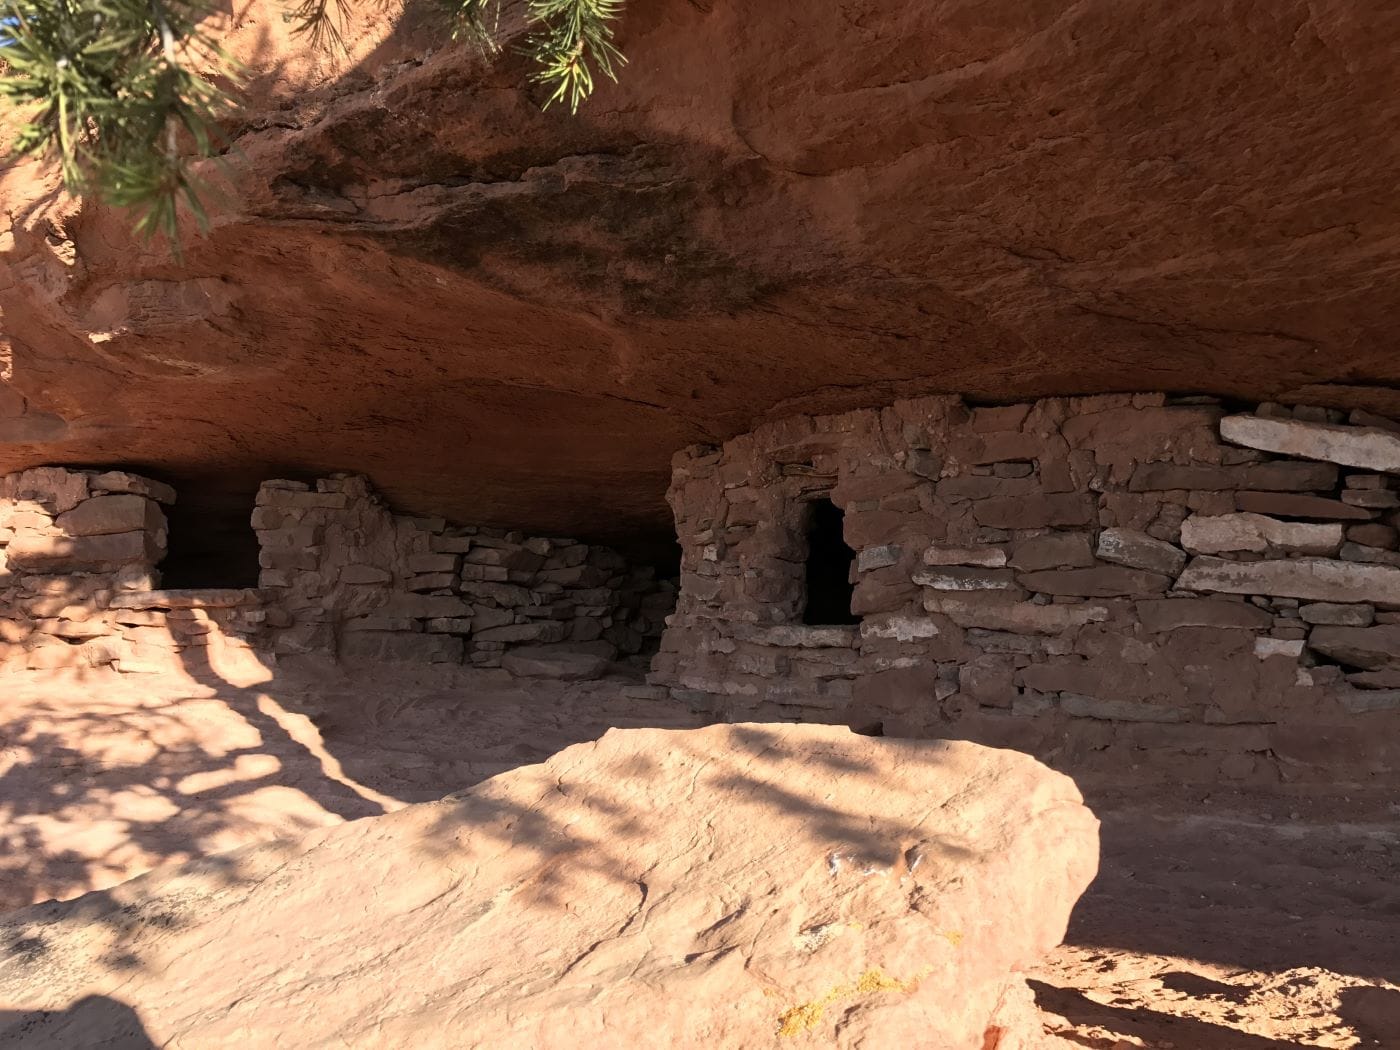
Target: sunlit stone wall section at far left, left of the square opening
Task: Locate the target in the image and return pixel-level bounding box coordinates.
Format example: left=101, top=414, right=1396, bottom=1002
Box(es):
left=0, top=468, right=262, bottom=673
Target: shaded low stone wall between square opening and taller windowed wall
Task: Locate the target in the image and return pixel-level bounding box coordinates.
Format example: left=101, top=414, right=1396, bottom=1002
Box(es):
left=253, top=475, right=675, bottom=668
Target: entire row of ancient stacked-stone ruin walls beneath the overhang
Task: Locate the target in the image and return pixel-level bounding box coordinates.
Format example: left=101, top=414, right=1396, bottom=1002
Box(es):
left=8, top=395, right=1400, bottom=784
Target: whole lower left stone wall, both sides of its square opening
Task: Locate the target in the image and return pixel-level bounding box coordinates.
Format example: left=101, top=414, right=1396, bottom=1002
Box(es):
left=0, top=468, right=675, bottom=673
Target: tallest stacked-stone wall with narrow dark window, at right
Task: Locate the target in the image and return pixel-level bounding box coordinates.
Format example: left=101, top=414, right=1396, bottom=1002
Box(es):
left=651, top=395, right=1400, bottom=784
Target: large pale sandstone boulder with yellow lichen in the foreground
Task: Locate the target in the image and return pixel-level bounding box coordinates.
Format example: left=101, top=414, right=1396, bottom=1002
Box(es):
left=0, top=725, right=1098, bottom=1050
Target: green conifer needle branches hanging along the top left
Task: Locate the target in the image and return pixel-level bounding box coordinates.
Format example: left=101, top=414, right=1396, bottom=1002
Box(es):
left=0, top=0, right=626, bottom=244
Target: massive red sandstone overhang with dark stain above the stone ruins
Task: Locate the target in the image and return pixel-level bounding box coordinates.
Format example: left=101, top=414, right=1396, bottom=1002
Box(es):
left=0, top=0, right=1400, bottom=560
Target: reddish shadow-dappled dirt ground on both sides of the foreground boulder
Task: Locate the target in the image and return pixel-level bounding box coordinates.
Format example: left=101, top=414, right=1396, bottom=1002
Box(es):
left=0, top=665, right=1400, bottom=1050
